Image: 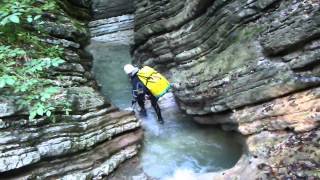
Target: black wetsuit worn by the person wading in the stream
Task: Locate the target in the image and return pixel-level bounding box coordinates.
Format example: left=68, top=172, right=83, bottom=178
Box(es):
left=131, top=73, right=163, bottom=121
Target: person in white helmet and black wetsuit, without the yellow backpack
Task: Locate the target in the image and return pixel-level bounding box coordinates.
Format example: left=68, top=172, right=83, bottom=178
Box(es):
left=123, top=64, right=169, bottom=124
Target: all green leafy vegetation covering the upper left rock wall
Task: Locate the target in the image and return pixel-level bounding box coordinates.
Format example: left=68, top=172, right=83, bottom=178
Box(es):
left=0, top=0, right=70, bottom=120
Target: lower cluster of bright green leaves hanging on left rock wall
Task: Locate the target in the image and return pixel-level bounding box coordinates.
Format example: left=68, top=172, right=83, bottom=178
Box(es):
left=0, top=46, right=70, bottom=120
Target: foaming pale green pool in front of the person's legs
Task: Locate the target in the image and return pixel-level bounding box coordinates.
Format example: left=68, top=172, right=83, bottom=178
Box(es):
left=97, top=92, right=243, bottom=180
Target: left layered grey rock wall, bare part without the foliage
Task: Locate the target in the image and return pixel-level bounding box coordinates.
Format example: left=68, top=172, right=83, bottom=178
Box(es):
left=0, top=0, right=143, bottom=179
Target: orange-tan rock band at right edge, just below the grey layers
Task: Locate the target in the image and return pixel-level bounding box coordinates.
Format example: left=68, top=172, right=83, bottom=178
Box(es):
left=234, top=88, right=320, bottom=134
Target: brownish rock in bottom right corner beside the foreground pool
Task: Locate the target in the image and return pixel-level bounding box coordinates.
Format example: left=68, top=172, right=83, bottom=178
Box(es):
left=204, top=129, right=320, bottom=180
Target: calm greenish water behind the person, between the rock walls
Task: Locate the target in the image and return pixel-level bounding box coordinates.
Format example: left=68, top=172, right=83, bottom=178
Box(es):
left=87, top=41, right=131, bottom=108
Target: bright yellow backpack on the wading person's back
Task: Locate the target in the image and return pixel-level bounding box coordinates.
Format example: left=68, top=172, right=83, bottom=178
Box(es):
left=137, top=66, right=170, bottom=98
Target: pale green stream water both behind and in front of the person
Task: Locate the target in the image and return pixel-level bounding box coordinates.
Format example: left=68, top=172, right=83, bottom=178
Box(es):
left=88, top=42, right=242, bottom=179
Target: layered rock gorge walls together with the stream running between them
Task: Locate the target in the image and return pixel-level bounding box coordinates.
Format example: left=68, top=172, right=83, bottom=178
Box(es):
left=0, top=0, right=320, bottom=180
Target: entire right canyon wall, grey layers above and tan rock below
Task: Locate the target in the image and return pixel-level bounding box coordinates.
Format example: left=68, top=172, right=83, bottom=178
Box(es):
left=132, top=0, right=320, bottom=179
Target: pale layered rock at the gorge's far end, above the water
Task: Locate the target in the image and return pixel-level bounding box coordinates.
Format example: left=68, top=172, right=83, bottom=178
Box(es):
left=88, top=0, right=134, bottom=53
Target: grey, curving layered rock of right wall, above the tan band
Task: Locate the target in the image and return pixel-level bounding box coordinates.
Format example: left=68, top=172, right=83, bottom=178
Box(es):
left=134, top=0, right=320, bottom=115
